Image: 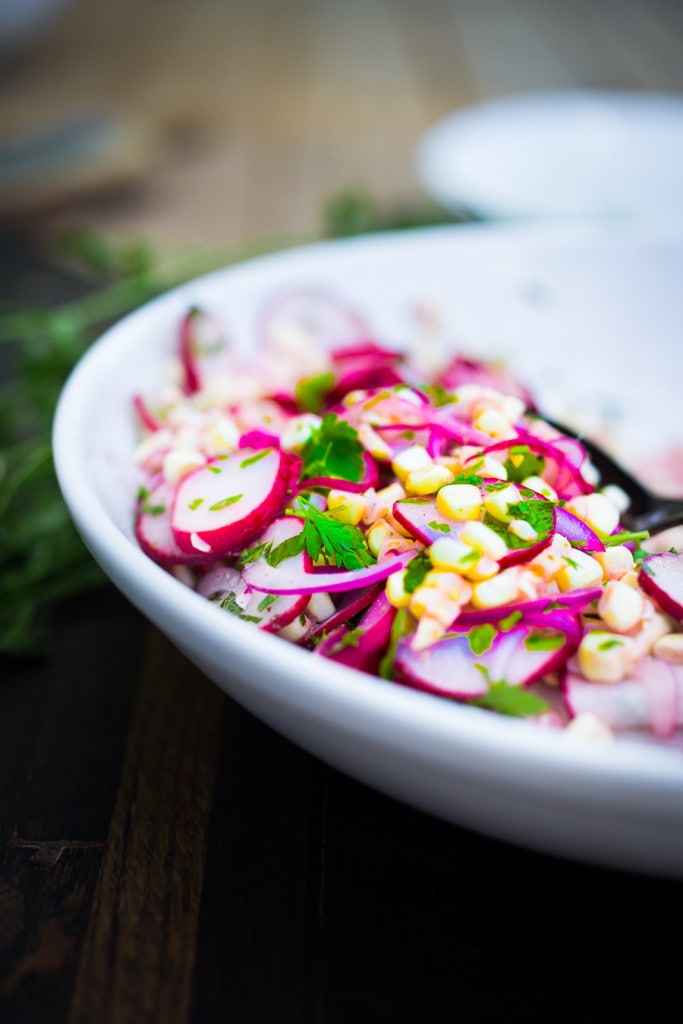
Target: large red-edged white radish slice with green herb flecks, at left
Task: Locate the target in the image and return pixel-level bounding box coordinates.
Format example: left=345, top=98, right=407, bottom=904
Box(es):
left=171, top=449, right=291, bottom=557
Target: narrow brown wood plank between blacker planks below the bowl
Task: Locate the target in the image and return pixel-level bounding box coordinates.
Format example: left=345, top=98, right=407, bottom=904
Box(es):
left=69, top=630, right=224, bottom=1024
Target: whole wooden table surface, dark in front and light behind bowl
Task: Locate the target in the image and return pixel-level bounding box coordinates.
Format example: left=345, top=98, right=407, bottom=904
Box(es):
left=0, top=0, right=683, bottom=1024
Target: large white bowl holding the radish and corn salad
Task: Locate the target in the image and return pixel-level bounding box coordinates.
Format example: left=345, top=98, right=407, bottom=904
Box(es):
left=54, top=227, right=683, bottom=876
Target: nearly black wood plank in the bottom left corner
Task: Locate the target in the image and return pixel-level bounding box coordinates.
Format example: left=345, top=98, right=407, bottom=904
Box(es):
left=0, top=588, right=145, bottom=1024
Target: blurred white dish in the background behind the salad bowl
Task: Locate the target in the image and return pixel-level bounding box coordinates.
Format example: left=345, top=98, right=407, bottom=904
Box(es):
left=417, top=90, right=683, bottom=223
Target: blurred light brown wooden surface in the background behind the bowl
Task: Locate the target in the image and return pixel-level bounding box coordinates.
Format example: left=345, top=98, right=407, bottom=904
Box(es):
left=0, top=0, right=683, bottom=244
